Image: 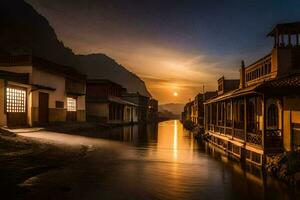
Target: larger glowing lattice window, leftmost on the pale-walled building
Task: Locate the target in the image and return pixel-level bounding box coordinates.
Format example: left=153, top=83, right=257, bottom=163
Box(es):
left=6, top=88, right=26, bottom=113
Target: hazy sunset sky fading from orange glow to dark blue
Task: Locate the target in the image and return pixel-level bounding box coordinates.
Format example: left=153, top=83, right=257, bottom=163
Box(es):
left=27, top=0, right=300, bottom=103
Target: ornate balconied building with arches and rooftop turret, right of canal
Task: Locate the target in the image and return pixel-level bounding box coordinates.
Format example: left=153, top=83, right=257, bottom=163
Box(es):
left=205, top=22, right=300, bottom=165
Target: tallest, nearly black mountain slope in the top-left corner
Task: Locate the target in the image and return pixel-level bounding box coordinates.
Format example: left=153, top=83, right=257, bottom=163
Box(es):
left=0, top=0, right=78, bottom=66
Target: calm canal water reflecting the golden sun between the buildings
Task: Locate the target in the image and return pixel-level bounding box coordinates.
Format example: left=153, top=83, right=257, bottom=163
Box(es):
left=20, top=121, right=300, bottom=200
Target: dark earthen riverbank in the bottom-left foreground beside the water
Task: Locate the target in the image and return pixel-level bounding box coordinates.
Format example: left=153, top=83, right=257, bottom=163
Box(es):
left=0, top=131, right=87, bottom=199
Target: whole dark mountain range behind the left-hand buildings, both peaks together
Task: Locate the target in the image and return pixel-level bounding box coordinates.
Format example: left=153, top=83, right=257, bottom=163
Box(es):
left=0, top=0, right=150, bottom=96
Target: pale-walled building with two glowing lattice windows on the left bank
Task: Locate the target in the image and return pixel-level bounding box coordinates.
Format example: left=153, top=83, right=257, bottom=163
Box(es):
left=0, top=55, right=86, bottom=126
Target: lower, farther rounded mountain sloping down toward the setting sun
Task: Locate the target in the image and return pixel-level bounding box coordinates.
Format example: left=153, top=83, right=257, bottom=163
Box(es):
left=77, top=54, right=151, bottom=97
